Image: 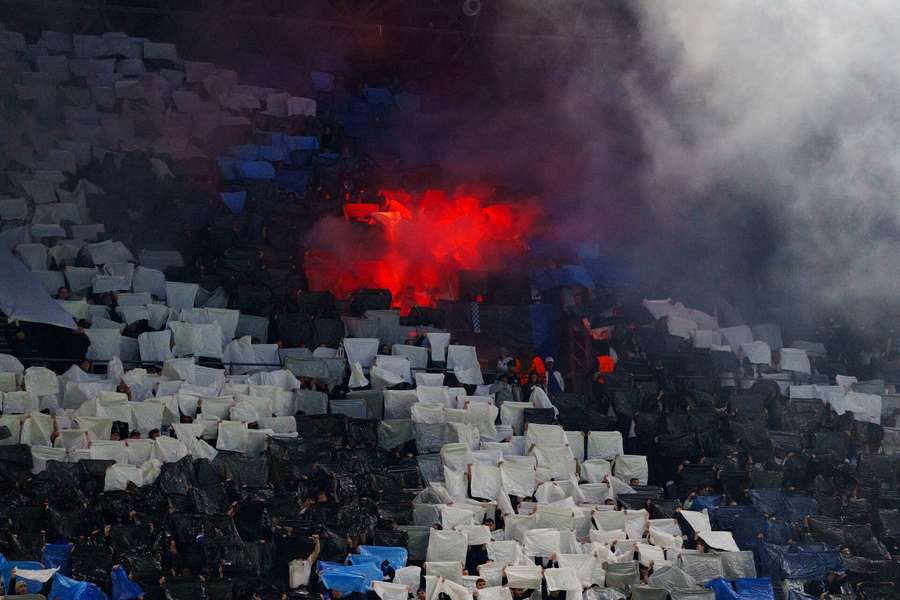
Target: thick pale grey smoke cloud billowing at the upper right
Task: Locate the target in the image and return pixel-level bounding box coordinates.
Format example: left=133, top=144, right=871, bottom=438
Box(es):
left=627, top=0, right=900, bottom=317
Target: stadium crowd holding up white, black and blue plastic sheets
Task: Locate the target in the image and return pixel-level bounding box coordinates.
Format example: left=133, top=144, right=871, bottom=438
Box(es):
left=0, top=18, right=900, bottom=600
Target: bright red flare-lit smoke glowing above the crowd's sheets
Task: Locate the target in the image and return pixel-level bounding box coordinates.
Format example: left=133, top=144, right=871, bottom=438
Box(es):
left=305, top=189, right=541, bottom=314
